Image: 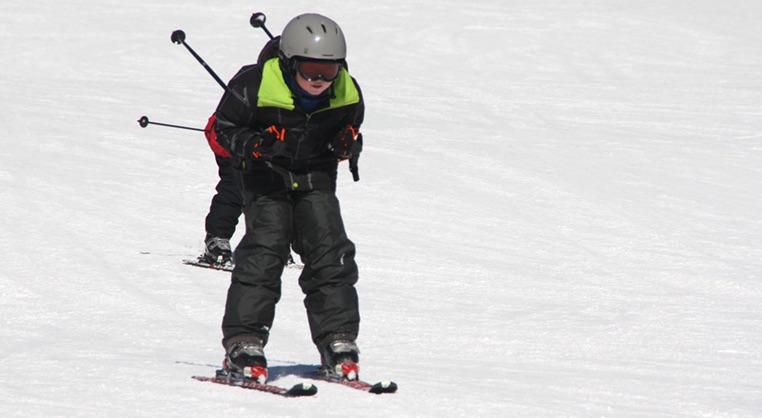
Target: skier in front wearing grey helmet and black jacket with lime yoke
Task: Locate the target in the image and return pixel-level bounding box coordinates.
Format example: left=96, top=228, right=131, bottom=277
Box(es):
left=216, top=14, right=364, bottom=383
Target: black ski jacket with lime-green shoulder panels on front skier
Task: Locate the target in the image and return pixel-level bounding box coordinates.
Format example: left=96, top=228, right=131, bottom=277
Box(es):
left=215, top=58, right=365, bottom=194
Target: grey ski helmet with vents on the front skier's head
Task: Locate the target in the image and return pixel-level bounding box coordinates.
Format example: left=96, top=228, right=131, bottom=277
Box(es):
left=280, top=13, right=347, bottom=61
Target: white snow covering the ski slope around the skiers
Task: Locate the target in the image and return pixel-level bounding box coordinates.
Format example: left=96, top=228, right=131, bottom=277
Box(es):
left=0, top=0, right=762, bottom=417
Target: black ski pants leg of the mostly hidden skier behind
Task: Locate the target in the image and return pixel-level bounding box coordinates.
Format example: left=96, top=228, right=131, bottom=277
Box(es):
left=205, top=155, right=243, bottom=239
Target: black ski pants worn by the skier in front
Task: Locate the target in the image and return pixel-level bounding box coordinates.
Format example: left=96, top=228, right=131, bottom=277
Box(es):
left=222, top=190, right=360, bottom=349
